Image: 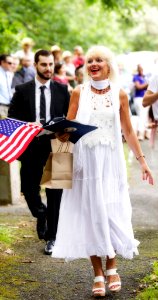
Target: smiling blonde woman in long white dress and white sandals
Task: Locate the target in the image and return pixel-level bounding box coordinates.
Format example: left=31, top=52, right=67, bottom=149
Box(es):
left=52, top=46, right=153, bottom=297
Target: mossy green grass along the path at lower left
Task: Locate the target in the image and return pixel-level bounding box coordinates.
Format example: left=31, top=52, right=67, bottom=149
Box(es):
left=0, top=215, right=35, bottom=300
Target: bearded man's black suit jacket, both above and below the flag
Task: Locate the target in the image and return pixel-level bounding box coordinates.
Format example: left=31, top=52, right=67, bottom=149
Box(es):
left=8, top=80, right=70, bottom=165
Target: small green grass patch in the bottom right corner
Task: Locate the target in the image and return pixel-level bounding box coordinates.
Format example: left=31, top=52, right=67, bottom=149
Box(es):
left=136, top=261, right=158, bottom=300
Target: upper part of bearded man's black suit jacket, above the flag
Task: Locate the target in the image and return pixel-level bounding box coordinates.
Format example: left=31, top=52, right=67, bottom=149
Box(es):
left=8, top=80, right=69, bottom=122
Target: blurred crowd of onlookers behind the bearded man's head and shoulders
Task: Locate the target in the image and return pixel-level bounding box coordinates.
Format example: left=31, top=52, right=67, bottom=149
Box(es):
left=0, top=37, right=85, bottom=117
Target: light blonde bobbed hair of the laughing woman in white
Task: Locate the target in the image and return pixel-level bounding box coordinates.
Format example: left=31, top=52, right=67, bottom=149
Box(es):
left=85, top=45, right=118, bottom=82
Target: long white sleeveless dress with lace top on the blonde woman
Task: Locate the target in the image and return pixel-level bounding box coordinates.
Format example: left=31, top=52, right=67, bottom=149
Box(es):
left=52, top=87, right=139, bottom=260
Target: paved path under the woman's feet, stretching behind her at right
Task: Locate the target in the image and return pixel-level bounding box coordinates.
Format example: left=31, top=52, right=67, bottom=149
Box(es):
left=0, top=137, right=158, bottom=300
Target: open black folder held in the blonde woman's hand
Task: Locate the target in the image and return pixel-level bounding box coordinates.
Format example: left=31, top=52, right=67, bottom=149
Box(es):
left=43, top=117, right=97, bottom=144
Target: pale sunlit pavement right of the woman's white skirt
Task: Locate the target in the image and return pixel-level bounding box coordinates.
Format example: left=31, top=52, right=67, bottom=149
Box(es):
left=129, top=140, right=158, bottom=229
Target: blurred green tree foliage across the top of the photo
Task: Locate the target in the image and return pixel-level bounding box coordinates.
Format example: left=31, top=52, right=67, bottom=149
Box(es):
left=0, top=0, right=158, bottom=53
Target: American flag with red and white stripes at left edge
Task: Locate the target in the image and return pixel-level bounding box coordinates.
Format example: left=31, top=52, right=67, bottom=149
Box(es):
left=0, top=118, right=43, bottom=163
